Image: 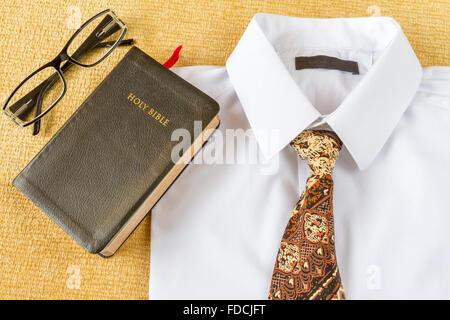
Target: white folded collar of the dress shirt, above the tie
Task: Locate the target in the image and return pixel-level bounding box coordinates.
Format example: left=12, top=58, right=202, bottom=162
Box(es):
left=226, top=14, right=422, bottom=170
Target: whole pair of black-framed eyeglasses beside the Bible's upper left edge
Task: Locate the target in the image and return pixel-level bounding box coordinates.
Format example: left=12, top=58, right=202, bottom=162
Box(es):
left=3, top=9, right=133, bottom=135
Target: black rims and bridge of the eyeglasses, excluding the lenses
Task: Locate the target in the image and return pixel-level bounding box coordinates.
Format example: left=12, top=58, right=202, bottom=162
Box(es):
left=3, top=9, right=133, bottom=135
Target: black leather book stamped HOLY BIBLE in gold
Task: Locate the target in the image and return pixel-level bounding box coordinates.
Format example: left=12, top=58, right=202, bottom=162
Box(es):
left=13, top=47, right=219, bottom=257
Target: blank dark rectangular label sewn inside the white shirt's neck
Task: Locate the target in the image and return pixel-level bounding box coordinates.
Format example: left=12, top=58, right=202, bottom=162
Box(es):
left=295, top=55, right=359, bottom=74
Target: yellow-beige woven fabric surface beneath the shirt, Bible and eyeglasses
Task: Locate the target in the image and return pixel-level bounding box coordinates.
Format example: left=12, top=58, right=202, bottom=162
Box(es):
left=0, top=0, right=450, bottom=299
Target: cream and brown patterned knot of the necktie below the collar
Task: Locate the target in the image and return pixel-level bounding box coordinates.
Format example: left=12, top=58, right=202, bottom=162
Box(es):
left=291, top=130, right=342, bottom=176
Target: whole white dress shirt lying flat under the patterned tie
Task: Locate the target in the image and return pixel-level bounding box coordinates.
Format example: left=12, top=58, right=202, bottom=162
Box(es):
left=149, top=14, right=450, bottom=299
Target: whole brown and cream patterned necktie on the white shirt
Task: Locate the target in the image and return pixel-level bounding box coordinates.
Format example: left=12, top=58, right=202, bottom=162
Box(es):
left=269, top=130, right=345, bottom=300
